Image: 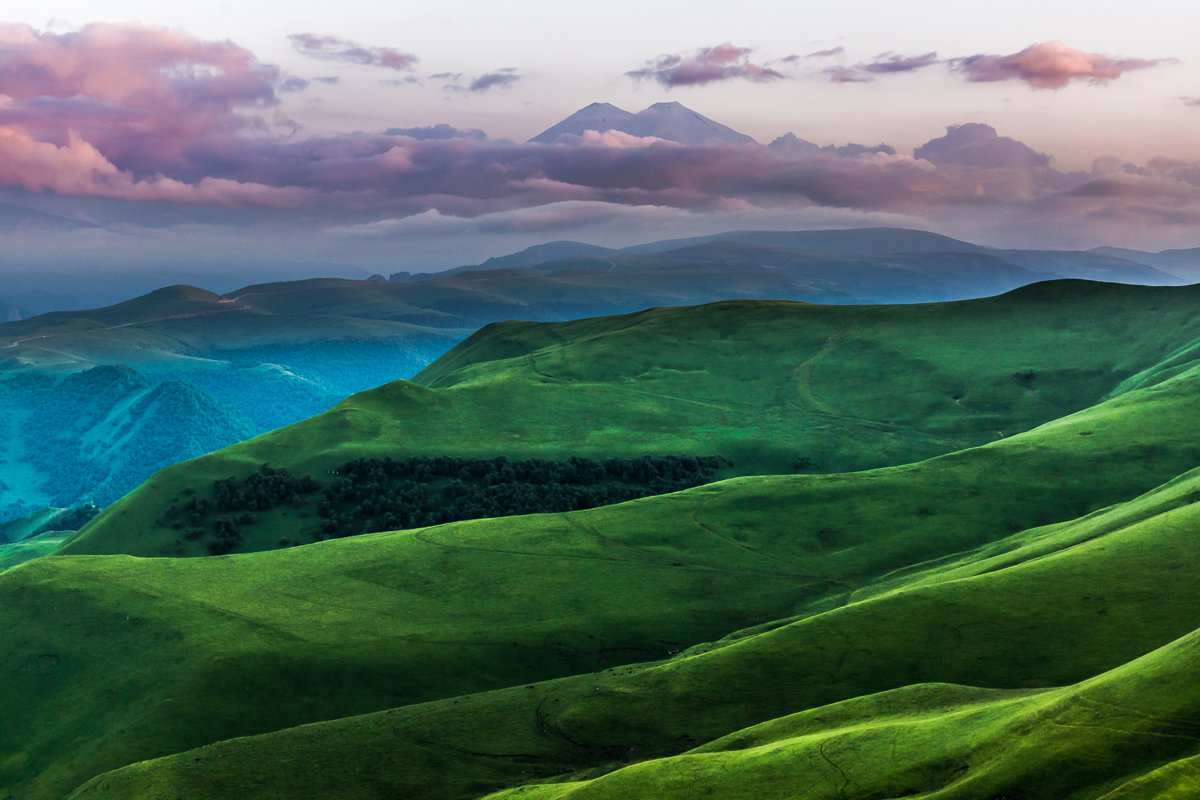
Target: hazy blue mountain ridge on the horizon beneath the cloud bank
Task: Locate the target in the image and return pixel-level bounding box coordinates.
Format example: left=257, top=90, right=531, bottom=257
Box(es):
left=451, top=228, right=1200, bottom=289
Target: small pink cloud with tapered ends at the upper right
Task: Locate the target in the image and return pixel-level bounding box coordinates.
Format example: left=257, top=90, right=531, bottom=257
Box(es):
left=954, top=42, right=1172, bottom=89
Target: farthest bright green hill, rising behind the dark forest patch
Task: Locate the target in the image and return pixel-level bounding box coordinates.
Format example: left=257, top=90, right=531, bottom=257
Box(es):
left=64, top=282, right=1200, bottom=555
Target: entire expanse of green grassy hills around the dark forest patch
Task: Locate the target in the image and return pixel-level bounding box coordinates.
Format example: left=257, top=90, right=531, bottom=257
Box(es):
left=7, top=282, right=1200, bottom=800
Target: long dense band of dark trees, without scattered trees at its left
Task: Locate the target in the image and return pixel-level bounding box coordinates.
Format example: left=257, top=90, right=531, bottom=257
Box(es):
left=318, top=456, right=728, bottom=537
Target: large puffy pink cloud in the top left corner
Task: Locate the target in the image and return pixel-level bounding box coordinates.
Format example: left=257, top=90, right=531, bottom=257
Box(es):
left=0, top=23, right=283, bottom=174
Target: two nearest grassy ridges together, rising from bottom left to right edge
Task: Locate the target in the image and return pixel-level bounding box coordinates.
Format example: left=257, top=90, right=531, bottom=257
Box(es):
left=63, top=460, right=1200, bottom=800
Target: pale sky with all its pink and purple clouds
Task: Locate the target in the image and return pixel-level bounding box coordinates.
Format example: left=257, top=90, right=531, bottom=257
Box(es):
left=0, top=0, right=1200, bottom=287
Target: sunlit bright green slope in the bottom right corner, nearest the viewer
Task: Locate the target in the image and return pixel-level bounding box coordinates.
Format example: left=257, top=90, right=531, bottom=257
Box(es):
left=470, top=632, right=1200, bottom=800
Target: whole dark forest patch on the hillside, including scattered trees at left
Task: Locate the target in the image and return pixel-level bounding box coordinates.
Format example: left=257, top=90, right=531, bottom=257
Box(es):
left=160, top=456, right=732, bottom=555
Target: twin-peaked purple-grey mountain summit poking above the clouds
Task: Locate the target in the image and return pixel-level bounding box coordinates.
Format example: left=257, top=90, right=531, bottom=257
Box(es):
left=529, top=103, right=757, bottom=145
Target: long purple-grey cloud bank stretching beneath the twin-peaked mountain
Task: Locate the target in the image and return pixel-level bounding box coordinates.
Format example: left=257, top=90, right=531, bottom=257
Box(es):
left=169, top=110, right=1200, bottom=250
